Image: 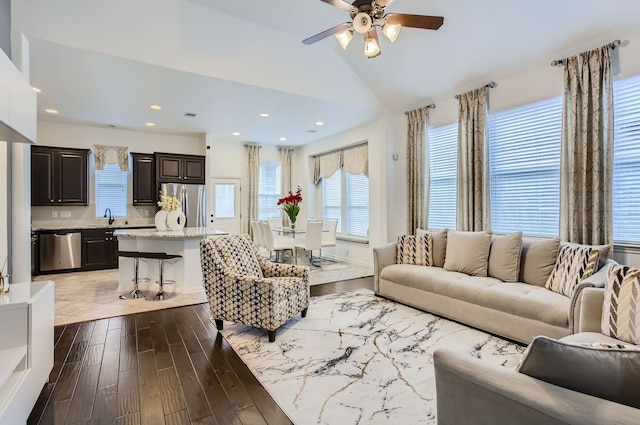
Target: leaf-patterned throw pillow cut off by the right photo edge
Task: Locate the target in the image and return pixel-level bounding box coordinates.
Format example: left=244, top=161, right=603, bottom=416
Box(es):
left=601, top=264, right=640, bottom=344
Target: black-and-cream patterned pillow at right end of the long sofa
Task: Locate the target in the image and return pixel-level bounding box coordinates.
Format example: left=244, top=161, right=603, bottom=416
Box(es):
left=544, top=245, right=600, bottom=297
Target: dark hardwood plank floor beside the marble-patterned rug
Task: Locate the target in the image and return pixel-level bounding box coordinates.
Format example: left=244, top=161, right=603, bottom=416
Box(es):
left=27, top=277, right=373, bottom=425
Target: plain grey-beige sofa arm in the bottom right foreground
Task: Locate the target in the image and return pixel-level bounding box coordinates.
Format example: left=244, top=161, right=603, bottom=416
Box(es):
left=433, top=349, right=640, bottom=425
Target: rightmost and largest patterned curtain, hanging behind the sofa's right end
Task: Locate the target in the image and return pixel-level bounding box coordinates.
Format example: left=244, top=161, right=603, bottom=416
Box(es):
left=560, top=45, right=613, bottom=244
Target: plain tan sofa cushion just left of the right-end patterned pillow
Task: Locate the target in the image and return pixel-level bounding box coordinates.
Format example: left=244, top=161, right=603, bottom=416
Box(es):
left=518, top=238, right=560, bottom=286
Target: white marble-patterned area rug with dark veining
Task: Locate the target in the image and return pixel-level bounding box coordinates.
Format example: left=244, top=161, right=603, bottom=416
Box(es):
left=222, top=289, right=525, bottom=425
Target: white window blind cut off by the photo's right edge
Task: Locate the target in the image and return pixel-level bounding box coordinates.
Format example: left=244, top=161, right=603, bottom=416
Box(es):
left=613, top=76, right=640, bottom=244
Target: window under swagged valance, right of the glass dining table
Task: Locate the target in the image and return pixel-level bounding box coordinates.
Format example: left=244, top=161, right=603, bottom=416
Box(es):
left=322, top=169, right=369, bottom=238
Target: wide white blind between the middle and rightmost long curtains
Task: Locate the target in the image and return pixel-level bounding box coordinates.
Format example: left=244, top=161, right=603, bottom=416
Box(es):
left=489, top=98, right=562, bottom=236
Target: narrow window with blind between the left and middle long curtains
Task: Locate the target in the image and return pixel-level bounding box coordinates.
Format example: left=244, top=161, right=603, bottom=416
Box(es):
left=428, top=124, right=458, bottom=229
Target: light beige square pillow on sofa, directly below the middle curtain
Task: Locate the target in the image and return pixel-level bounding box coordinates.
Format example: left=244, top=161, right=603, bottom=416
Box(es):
left=444, top=230, right=491, bottom=276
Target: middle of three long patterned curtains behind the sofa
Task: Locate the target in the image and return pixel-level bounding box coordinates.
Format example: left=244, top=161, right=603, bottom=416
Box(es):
left=456, top=86, right=491, bottom=231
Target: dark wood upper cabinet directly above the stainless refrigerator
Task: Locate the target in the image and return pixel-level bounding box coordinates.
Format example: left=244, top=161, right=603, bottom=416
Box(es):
left=156, top=153, right=205, bottom=184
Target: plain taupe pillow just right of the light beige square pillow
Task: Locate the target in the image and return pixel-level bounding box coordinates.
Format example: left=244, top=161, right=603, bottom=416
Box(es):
left=488, top=232, right=522, bottom=282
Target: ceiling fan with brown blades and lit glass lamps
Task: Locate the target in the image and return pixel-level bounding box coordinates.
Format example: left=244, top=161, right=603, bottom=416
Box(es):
left=302, top=0, right=444, bottom=59
